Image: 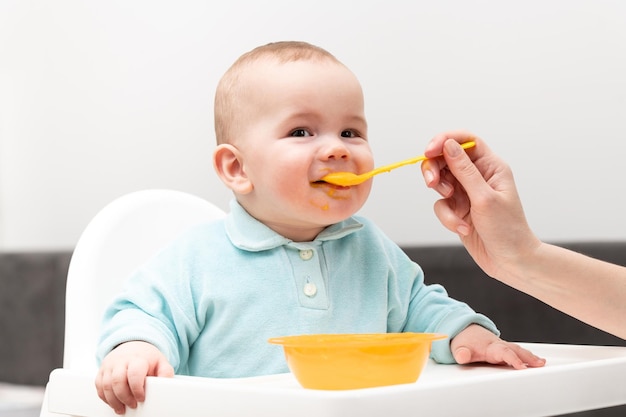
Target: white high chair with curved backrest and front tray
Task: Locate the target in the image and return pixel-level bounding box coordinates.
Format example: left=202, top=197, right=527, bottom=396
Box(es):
left=41, top=190, right=626, bottom=417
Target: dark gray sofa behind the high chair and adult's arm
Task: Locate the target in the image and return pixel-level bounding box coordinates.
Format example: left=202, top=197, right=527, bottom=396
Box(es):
left=0, top=241, right=626, bottom=417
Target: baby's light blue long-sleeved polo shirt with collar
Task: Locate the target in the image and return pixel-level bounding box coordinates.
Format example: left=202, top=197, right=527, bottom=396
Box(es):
left=97, top=201, right=499, bottom=378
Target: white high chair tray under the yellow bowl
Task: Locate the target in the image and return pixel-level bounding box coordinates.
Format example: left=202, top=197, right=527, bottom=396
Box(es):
left=42, top=343, right=626, bottom=417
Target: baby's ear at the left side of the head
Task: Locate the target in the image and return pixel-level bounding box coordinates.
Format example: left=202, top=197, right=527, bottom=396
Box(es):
left=213, top=143, right=254, bottom=195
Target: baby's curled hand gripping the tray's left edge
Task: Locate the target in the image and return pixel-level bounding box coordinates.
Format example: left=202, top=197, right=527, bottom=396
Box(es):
left=96, top=342, right=174, bottom=414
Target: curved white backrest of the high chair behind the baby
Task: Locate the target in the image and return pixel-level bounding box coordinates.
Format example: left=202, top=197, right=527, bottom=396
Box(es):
left=63, top=190, right=225, bottom=370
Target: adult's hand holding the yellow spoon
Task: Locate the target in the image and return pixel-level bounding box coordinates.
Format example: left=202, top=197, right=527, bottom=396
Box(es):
left=422, top=131, right=541, bottom=277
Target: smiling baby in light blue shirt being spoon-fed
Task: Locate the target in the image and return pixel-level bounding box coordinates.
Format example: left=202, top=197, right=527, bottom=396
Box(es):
left=96, top=42, right=544, bottom=414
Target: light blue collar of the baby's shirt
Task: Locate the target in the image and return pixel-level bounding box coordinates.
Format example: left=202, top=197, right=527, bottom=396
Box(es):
left=225, top=200, right=363, bottom=252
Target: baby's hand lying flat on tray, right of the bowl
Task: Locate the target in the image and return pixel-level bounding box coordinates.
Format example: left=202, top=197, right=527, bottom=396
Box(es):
left=450, top=324, right=546, bottom=369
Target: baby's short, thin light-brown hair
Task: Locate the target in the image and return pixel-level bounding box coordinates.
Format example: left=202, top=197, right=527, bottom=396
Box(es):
left=214, top=41, right=340, bottom=144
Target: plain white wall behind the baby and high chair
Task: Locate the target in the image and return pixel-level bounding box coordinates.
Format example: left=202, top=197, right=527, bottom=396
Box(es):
left=0, top=0, right=626, bottom=251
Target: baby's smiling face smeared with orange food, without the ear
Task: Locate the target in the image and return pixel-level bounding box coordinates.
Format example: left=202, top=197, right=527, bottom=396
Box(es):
left=235, top=60, right=374, bottom=241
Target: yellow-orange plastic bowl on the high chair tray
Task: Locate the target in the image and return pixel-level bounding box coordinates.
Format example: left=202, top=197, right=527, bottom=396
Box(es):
left=269, top=333, right=447, bottom=390
